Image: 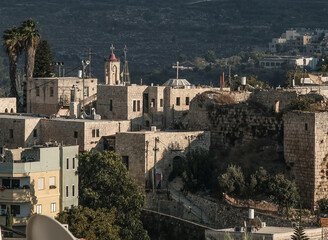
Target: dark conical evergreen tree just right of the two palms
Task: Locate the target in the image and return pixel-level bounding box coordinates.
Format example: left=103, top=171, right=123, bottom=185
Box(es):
left=33, top=40, right=55, bottom=77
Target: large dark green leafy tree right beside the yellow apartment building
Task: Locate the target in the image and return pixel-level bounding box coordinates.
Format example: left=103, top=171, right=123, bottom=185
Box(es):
left=78, top=151, right=149, bottom=240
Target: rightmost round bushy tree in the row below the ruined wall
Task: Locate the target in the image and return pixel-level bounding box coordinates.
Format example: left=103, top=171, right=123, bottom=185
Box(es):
left=268, top=174, right=300, bottom=217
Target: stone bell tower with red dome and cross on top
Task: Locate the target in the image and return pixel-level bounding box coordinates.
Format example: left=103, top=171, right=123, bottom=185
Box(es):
left=105, top=44, right=121, bottom=85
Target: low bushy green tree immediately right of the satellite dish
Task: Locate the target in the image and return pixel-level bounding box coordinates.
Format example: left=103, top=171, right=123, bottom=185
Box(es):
left=56, top=206, right=121, bottom=240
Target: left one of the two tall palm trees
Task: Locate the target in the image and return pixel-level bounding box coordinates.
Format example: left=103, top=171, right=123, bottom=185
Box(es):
left=2, top=26, right=23, bottom=99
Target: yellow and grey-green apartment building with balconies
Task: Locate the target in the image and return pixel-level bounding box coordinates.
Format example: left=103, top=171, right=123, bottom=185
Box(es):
left=0, top=146, right=78, bottom=227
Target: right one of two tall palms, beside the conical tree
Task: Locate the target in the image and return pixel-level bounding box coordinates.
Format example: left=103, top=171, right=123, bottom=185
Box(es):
left=20, top=18, right=41, bottom=79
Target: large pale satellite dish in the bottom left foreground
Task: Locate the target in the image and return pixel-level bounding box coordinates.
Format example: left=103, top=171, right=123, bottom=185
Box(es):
left=26, top=214, right=77, bottom=240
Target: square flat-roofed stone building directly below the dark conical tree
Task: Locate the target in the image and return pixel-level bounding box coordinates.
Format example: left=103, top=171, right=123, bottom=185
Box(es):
left=27, top=77, right=98, bottom=116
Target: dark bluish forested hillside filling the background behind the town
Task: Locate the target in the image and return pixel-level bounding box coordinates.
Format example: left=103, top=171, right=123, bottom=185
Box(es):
left=0, top=0, right=328, bottom=83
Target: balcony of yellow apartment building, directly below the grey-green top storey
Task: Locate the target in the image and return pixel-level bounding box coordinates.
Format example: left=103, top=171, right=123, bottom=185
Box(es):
left=0, top=189, right=31, bottom=203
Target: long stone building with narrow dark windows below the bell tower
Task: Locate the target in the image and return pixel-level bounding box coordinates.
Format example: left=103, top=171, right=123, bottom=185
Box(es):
left=97, top=84, right=219, bottom=130
